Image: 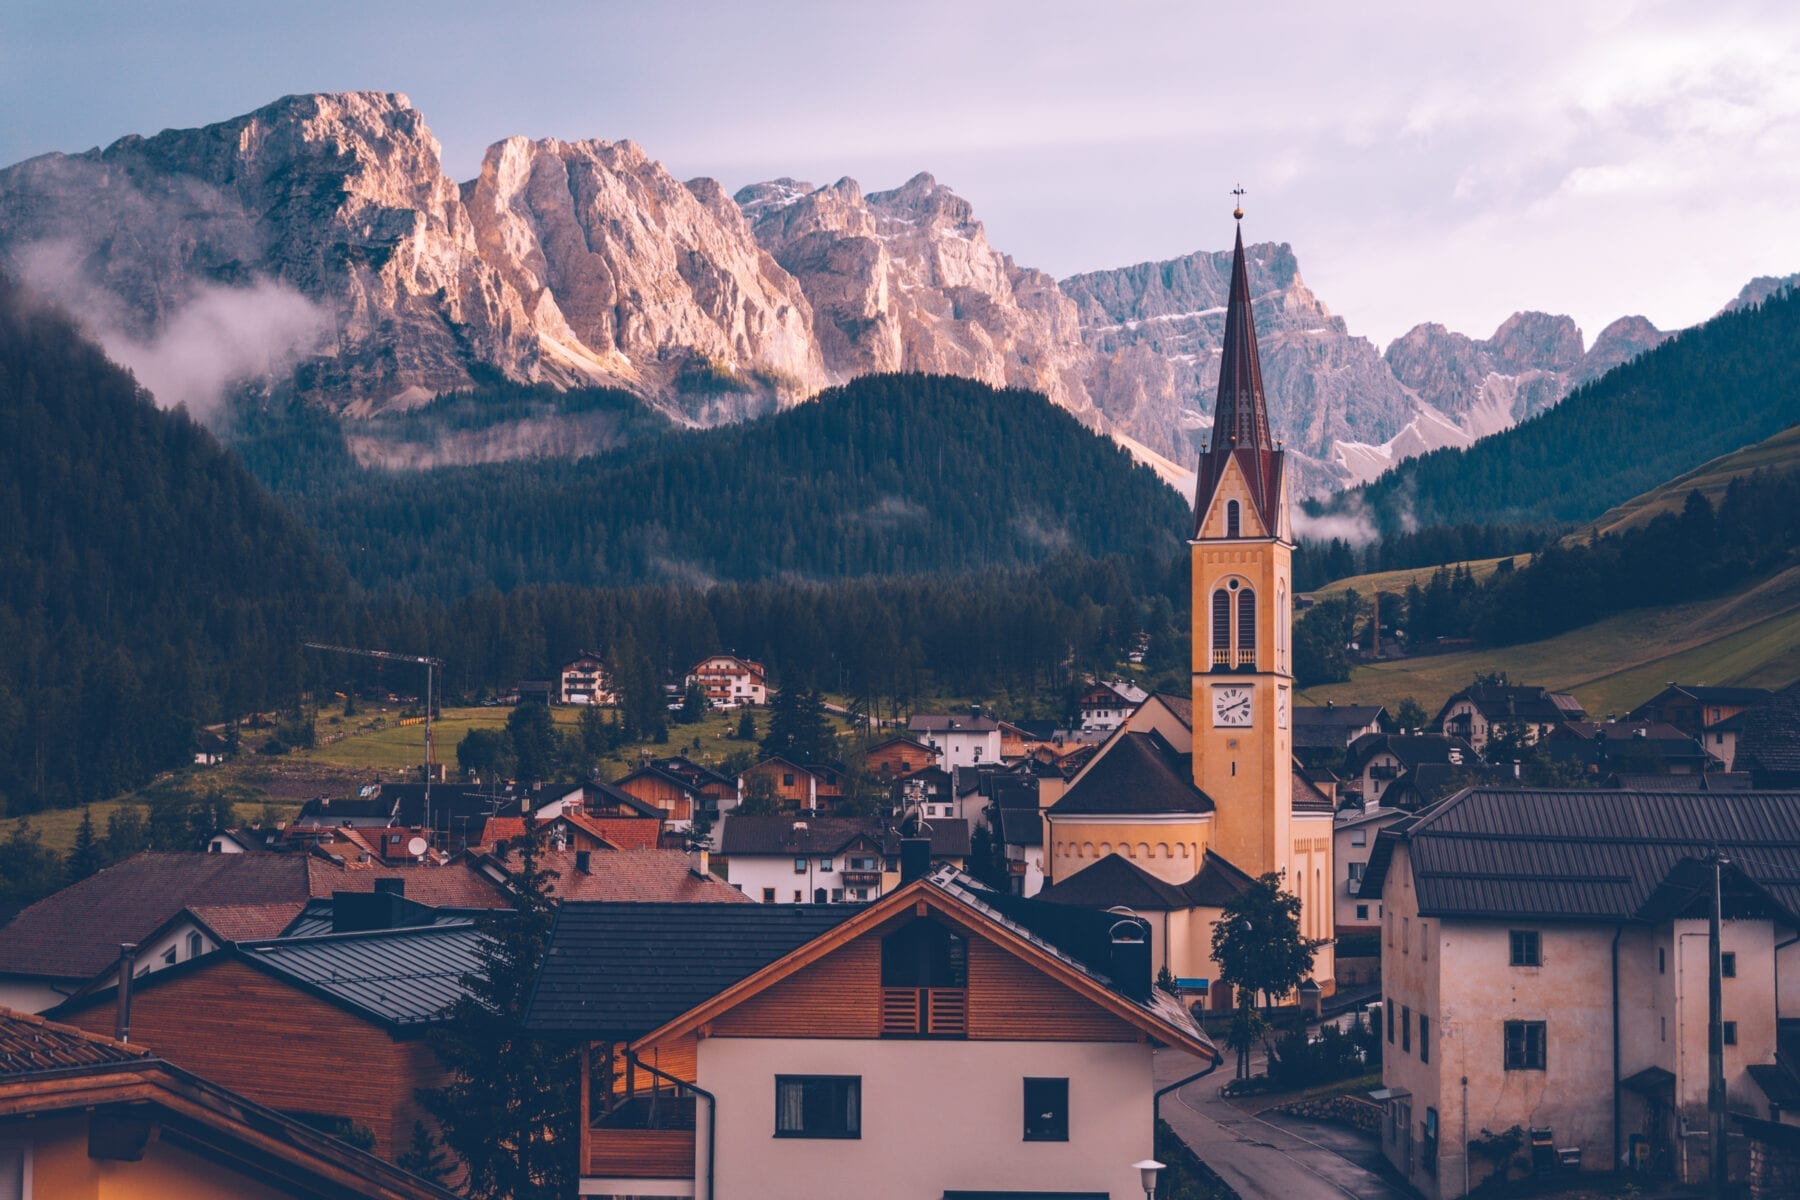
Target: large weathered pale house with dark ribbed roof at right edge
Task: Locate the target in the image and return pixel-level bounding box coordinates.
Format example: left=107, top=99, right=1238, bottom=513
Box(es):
left=1363, top=788, right=1800, bottom=1200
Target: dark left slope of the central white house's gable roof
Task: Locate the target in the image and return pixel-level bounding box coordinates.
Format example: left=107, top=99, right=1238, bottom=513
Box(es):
left=526, top=901, right=862, bottom=1038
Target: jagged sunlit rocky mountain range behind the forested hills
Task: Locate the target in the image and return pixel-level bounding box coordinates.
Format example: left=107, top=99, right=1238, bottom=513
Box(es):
left=0, top=92, right=1699, bottom=489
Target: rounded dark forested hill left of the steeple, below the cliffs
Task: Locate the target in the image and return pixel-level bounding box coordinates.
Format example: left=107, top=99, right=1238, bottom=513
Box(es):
left=243, top=374, right=1190, bottom=597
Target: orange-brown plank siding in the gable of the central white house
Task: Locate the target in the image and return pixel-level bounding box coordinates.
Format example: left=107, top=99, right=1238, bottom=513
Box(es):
left=680, top=925, right=1138, bottom=1042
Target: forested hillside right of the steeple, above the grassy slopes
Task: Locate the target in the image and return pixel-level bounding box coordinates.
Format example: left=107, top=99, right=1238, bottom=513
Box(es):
left=1325, top=290, right=1800, bottom=533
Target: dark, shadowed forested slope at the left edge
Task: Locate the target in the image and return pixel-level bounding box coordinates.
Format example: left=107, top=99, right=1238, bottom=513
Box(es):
left=0, top=279, right=346, bottom=808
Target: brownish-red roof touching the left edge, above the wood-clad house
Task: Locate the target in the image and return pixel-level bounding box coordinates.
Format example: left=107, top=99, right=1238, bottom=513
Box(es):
left=0, top=851, right=309, bottom=979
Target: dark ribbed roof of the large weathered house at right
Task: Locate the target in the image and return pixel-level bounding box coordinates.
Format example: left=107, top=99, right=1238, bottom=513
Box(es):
left=1363, top=788, right=1800, bottom=921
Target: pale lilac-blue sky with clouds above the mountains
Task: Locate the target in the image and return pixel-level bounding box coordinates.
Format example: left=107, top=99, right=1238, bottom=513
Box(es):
left=0, top=0, right=1800, bottom=345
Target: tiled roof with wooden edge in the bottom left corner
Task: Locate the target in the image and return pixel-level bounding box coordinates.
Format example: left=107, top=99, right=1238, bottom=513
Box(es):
left=0, top=1007, right=455, bottom=1200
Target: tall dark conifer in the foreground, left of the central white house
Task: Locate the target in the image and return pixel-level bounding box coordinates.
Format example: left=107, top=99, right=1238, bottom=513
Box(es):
left=421, top=815, right=580, bottom=1200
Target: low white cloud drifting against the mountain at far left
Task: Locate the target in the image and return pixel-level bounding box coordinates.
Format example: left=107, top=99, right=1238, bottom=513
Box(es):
left=16, top=243, right=333, bottom=421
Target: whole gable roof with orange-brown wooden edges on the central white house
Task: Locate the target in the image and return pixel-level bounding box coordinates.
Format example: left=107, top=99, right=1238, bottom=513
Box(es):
left=526, top=867, right=1219, bottom=1061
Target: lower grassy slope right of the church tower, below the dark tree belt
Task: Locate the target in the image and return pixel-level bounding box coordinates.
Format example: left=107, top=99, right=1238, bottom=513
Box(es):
left=1301, top=567, right=1800, bottom=714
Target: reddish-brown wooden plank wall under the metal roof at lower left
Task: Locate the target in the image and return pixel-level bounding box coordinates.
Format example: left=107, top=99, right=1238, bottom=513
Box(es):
left=59, top=959, right=448, bottom=1159
